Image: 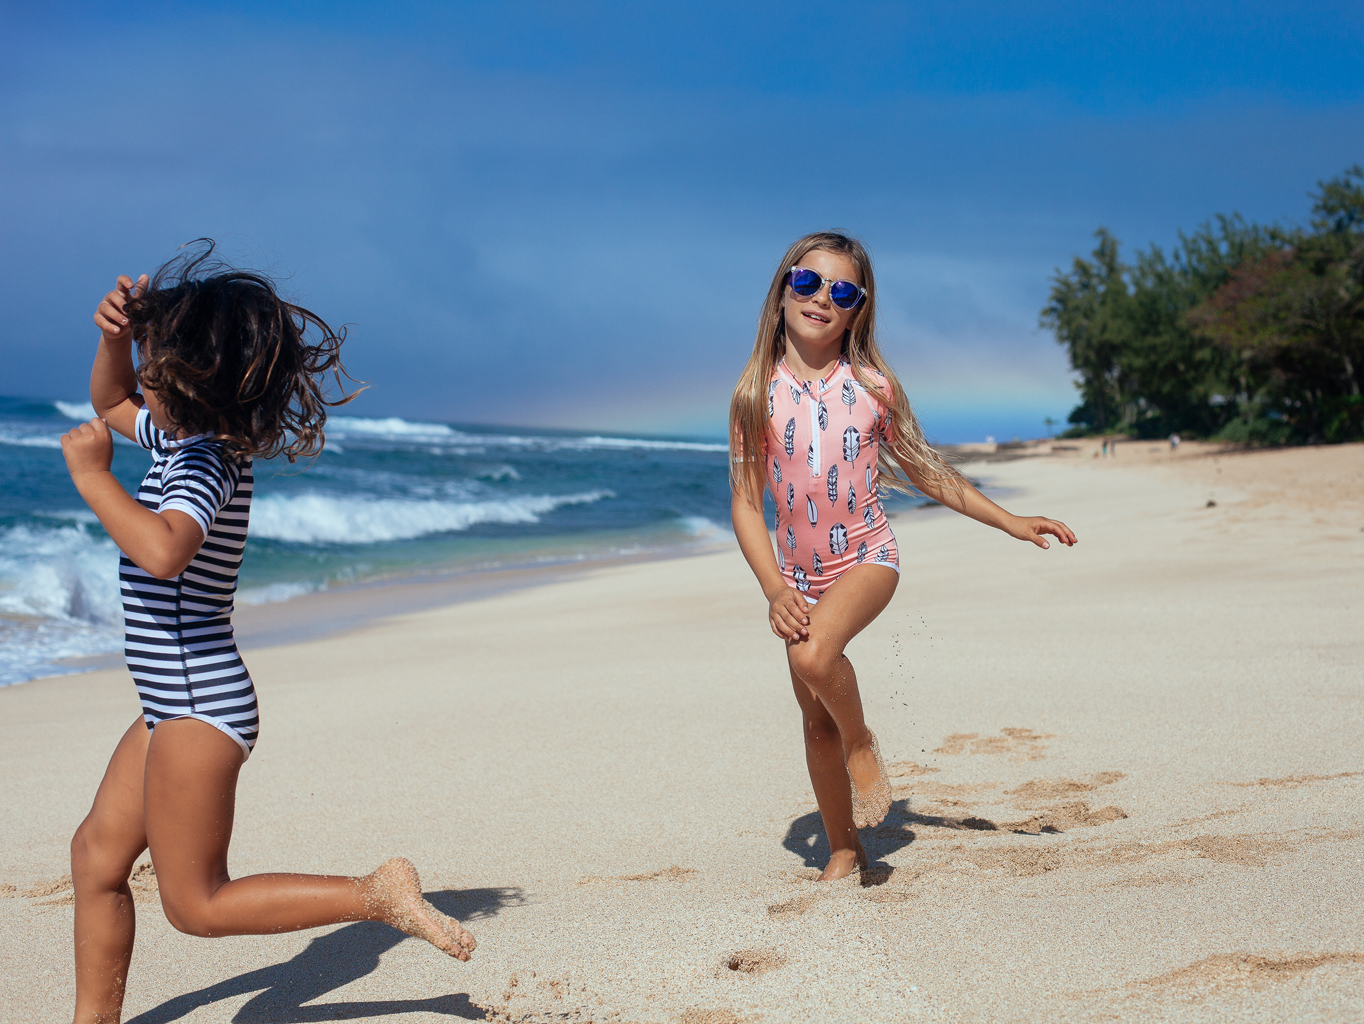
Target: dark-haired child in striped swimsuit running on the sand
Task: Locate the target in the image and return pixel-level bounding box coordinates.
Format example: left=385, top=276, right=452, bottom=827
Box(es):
left=61, top=243, right=475, bottom=1024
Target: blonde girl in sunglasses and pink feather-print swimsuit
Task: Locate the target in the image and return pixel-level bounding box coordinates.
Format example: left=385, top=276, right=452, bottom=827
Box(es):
left=730, top=232, right=1075, bottom=881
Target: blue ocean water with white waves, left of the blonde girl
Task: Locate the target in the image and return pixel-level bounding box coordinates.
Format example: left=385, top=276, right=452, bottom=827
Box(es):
left=0, top=398, right=732, bottom=684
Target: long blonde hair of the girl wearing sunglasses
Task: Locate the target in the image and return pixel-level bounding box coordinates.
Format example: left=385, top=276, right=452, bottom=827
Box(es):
left=730, top=232, right=962, bottom=509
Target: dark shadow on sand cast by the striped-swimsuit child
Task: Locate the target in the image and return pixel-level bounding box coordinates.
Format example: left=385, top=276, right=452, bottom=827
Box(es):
left=127, top=886, right=527, bottom=1024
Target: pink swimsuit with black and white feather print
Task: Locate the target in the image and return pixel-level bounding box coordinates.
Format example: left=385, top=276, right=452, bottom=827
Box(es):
left=762, top=359, right=900, bottom=601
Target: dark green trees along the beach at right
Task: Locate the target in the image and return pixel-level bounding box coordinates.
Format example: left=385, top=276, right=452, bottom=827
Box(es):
left=1041, top=165, right=1364, bottom=445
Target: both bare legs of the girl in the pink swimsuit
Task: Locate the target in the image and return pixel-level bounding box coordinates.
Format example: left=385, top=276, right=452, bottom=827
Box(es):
left=787, top=564, right=900, bottom=881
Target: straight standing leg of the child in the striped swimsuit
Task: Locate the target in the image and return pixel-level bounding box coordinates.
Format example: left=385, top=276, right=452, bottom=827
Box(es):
left=71, top=716, right=149, bottom=1024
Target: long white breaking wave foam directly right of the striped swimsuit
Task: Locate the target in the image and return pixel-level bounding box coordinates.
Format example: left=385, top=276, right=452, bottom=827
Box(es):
left=251, top=491, right=615, bottom=544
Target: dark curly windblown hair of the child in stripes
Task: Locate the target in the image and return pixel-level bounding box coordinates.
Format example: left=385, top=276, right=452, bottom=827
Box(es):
left=125, top=239, right=363, bottom=462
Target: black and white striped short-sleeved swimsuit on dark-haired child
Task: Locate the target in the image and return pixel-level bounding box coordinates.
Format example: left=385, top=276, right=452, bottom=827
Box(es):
left=119, top=409, right=261, bottom=757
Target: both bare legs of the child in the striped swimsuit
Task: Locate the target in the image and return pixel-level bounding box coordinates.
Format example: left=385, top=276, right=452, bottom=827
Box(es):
left=71, top=719, right=475, bottom=1024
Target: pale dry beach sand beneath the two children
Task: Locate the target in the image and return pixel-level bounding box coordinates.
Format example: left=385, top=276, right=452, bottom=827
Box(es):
left=0, top=443, right=1364, bottom=1024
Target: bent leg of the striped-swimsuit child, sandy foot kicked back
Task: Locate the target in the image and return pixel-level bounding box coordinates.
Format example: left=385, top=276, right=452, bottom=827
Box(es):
left=145, top=719, right=475, bottom=960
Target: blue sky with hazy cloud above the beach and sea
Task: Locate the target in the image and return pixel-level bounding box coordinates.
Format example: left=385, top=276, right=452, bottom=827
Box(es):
left=0, top=1, right=1364, bottom=440
